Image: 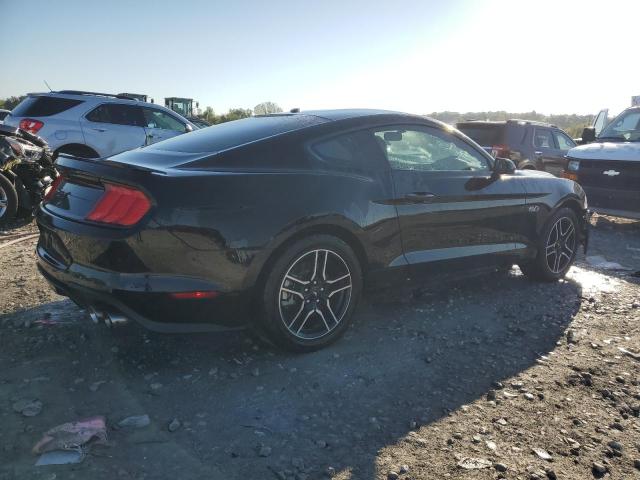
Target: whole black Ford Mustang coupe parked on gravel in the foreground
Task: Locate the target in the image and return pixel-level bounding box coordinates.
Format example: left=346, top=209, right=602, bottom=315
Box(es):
left=37, top=110, right=588, bottom=351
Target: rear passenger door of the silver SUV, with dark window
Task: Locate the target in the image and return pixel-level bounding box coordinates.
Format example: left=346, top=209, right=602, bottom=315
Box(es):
left=80, top=103, right=145, bottom=157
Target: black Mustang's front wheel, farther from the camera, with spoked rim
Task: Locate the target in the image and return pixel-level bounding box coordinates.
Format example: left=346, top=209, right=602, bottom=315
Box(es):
left=518, top=208, right=578, bottom=282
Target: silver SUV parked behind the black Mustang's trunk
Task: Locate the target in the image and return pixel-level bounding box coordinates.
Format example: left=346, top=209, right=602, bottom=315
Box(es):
left=4, top=90, right=198, bottom=158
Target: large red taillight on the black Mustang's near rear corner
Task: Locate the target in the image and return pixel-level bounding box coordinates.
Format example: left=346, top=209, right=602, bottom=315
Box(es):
left=86, top=183, right=151, bottom=227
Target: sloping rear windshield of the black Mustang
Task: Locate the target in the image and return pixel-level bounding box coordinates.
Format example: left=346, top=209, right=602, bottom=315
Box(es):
left=147, top=114, right=327, bottom=153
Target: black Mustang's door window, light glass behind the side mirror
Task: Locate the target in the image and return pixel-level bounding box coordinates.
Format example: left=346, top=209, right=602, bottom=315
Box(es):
left=374, top=127, right=490, bottom=171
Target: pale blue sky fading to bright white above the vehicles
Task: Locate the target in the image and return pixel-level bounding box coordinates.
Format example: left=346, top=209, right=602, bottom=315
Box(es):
left=0, top=0, right=640, bottom=114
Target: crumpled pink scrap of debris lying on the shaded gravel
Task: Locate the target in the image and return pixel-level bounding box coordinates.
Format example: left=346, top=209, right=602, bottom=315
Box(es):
left=33, top=416, right=107, bottom=454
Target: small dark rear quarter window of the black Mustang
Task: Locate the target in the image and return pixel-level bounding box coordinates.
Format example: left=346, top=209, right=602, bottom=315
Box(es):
left=311, top=130, right=386, bottom=172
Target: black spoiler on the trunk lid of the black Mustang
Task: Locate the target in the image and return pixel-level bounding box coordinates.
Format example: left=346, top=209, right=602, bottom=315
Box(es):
left=55, top=153, right=166, bottom=183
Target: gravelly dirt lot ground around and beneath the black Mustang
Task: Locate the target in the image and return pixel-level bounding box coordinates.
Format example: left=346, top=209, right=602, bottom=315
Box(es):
left=0, top=217, right=640, bottom=480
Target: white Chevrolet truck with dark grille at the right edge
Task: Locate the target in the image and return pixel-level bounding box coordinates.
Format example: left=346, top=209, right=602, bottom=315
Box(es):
left=564, top=106, right=640, bottom=219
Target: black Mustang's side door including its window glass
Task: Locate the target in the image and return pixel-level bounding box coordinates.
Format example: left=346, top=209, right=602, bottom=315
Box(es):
left=374, top=125, right=527, bottom=273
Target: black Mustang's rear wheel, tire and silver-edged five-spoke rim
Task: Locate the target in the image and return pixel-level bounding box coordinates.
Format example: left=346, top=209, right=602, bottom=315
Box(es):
left=262, top=235, right=362, bottom=352
